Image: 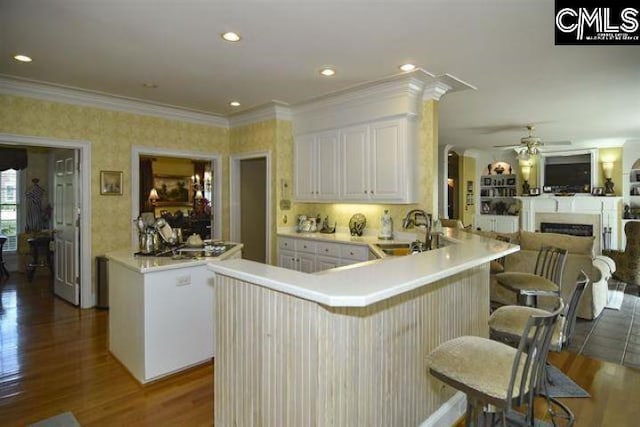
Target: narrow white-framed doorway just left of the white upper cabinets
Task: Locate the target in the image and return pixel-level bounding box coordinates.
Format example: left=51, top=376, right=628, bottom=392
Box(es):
left=230, top=152, right=271, bottom=264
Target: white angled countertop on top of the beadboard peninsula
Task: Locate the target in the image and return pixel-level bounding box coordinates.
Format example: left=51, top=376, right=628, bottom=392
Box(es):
left=208, top=228, right=520, bottom=307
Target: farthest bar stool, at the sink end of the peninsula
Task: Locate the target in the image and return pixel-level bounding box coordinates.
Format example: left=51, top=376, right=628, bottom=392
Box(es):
left=495, top=246, right=569, bottom=307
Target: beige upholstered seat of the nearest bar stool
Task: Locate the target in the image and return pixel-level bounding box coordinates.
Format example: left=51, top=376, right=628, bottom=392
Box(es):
left=427, top=338, right=528, bottom=400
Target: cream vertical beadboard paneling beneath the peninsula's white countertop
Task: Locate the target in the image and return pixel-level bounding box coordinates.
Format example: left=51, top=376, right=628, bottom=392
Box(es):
left=214, top=264, right=489, bottom=426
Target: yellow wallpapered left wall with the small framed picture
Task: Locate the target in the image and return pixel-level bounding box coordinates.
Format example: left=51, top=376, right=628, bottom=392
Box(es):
left=0, top=95, right=229, bottom=286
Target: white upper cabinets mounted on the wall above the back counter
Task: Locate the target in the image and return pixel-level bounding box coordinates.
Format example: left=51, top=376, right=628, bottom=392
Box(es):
left=295, top=118, right=417, bottom=203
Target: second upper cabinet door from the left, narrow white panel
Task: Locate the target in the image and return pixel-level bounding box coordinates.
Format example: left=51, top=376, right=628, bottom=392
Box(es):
left=314, top=131, right=340, bottom=200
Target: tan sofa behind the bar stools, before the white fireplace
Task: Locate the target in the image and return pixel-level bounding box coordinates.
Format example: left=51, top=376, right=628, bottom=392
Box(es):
left=476, top=231, right=615, bottom=319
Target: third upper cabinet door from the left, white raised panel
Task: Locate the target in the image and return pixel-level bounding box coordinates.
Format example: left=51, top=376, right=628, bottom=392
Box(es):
left=340, top=126, right=369, bottom=200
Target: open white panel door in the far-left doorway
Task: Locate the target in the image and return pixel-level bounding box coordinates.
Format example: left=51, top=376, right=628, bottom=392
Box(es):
left=53, top=150, right=80, bottom=305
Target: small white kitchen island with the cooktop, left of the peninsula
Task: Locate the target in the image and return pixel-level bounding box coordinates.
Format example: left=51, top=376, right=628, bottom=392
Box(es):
left=107, top=244, right=242, bottom=384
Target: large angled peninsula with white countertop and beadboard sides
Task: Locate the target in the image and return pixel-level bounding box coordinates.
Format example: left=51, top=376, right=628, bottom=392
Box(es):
left=208, top=229, right=519, bottom=426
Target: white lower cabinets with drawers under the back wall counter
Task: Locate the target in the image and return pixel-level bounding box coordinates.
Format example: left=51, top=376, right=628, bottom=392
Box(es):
left=278, top=237, right=369, bottom=273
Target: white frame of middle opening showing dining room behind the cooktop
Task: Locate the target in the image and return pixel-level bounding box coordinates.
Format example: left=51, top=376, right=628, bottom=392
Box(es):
left=131, top=145, right=222, bottom=248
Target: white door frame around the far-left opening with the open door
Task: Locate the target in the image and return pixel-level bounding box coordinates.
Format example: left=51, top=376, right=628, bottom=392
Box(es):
left=0, top=133, right=96, bottom=308
